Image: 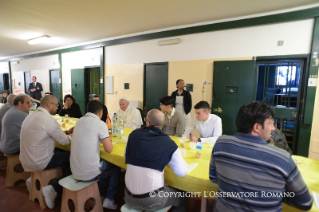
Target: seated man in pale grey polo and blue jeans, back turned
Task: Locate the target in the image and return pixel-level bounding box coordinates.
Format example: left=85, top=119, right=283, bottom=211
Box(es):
left=70, top=100, right=121, bottom=210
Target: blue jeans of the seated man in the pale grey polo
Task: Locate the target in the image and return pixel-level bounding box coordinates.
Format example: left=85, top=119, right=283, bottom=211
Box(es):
left=87, top=158, right=121, bottom=201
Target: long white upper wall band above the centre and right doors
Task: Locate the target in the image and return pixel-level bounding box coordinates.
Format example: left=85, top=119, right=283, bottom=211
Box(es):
left=106, top=19, right=314, bottom=65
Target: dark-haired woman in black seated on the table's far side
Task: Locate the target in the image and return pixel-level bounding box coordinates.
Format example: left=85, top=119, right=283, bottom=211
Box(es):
left=59, top=94, right=82, bottom=118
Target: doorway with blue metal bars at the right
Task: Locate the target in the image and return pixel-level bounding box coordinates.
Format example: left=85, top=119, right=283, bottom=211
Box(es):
left=256, top=59, right=304, bottom=152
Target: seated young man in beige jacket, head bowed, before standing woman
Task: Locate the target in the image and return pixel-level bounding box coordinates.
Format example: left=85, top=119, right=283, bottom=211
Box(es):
left=160, top=96, right=185, bottom=137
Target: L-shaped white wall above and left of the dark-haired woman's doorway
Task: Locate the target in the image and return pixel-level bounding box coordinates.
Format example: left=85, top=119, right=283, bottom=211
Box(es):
left=62, top=48, right=101, bottom=97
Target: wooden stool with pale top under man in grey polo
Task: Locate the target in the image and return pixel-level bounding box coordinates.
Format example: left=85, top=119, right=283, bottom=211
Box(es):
left=59, top=175, right=103, bottom=212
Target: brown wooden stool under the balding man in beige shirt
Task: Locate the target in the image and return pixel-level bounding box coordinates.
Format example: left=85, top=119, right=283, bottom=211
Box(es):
left=29, top=167, right=62, bottom=209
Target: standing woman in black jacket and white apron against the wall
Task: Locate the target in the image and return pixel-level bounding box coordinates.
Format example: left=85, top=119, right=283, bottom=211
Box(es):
left=171, top=79, right=192, bottom=127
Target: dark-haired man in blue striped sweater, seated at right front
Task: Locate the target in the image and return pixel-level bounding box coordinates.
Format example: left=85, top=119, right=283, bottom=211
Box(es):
left=209, top=102, right=313, bottom=212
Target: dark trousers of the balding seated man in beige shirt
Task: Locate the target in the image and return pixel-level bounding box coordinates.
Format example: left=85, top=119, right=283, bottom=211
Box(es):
left=44, top=149, right=72, bottom=195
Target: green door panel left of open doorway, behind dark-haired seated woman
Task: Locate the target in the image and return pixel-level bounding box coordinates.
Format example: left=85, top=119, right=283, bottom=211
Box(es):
left=71, top=69, right=86, bottom=115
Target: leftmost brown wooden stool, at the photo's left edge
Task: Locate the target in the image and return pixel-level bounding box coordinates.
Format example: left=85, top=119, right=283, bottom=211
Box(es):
left=6, top=155, right=31, bottom=187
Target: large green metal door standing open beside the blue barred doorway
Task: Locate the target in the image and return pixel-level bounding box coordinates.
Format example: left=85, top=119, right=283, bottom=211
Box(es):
left=212, top=60, right=257, bottom=135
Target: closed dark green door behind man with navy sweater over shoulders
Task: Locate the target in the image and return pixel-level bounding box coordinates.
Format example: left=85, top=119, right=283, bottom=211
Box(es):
left=144, top=63, right=168, bottom=111
